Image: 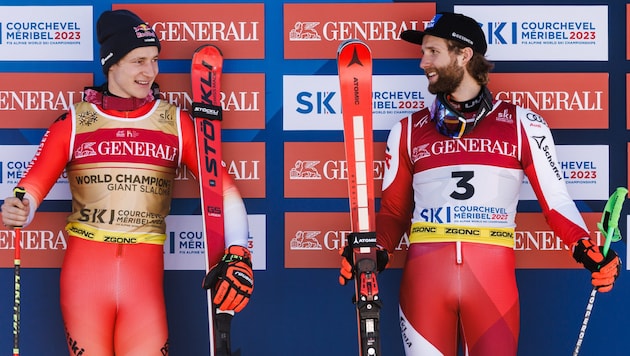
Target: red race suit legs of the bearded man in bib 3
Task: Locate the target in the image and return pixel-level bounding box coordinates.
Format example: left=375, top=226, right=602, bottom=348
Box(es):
left=399, top=242, right=519, bottom=356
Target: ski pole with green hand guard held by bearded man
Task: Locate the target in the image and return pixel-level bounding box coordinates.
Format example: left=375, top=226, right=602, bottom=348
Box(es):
left=573, top=187, right=628, bottom=356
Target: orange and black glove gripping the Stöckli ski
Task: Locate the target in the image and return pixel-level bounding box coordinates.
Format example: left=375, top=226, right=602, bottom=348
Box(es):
left=203, top=245, right=254, bottom=312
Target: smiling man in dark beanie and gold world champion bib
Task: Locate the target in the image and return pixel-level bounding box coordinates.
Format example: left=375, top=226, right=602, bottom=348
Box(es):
left=2, top=10, right=253, bottom=356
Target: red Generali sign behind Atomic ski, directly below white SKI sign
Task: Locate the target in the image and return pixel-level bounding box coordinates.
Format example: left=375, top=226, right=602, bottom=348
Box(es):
left=284, top=142, right=385, bottom=198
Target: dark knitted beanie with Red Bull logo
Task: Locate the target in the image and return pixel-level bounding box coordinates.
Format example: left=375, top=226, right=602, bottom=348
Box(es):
left=96, top=10, right=161, bottom=76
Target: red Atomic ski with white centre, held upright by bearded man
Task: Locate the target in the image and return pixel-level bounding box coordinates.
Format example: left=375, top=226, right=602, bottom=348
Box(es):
left=337, top=40, right=381, bottom=356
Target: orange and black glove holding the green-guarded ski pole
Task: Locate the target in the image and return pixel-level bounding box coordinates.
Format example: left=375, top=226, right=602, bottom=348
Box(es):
left=573, top=239, right=621, bottom=292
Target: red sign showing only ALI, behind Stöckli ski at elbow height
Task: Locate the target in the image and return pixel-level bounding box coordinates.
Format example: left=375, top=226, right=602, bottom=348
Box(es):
left=173, top=142, right=267, bottom=198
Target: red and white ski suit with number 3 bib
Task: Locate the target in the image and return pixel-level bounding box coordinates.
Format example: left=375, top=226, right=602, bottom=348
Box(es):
left=376, top=101, right=588, bottom=356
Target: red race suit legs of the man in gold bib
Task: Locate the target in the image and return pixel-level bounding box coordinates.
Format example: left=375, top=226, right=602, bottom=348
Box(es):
left=60, top=237, right=168, bottom=356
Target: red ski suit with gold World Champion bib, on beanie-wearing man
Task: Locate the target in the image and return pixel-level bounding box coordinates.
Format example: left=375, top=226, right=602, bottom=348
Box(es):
left=19, top=100, right=248, bottom=356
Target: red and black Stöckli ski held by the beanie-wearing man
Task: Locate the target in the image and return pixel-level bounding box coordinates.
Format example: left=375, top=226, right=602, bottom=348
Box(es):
left=190, top=45, right=233, bottom=356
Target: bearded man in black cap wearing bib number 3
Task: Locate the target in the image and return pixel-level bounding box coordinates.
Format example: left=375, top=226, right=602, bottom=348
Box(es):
left=342, top=12, right=621, bottom=356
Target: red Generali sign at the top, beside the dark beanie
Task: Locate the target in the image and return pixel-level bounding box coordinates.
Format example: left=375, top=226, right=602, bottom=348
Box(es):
left=112, top=4, right=265, bottom=59
